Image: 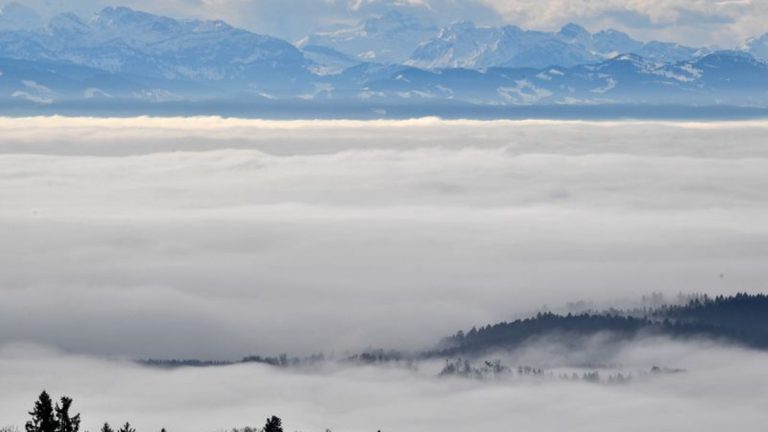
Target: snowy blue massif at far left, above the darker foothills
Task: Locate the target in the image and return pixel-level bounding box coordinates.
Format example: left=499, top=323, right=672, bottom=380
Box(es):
left=0, top=7, right=310, bottom=91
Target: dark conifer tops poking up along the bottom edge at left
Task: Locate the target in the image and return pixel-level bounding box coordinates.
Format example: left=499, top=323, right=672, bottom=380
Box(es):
left=24, top=391, right=283, bottom=432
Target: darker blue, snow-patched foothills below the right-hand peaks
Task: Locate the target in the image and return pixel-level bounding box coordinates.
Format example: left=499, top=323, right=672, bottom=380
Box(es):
left=316, top=52, right=768, bottom=106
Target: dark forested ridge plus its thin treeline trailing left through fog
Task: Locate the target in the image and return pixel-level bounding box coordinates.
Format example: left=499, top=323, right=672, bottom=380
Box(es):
left=136, top=294, right=768, bottom=368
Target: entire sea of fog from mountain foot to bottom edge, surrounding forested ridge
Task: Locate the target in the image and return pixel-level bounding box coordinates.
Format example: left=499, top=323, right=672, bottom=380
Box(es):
left=0, top=117, right=768, bottom=432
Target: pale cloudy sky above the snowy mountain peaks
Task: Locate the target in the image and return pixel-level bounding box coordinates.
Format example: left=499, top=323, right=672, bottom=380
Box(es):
left=10, top=0, right=768, bottom=47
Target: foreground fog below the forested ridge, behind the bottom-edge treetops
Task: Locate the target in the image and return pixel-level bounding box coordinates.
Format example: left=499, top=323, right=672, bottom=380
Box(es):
left=0, top=340, right=768, bottom=432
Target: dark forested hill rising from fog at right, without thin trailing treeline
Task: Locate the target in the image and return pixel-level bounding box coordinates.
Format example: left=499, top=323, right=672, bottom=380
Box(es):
left=436, top=294, right=768, bottom=357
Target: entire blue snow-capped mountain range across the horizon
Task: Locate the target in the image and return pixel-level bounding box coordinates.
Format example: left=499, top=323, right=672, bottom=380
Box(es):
left=0, top=3, right=768, bottom=107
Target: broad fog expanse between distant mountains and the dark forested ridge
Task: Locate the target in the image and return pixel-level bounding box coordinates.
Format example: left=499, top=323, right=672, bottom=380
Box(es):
left=0, top=118, right=768, bottom=358
